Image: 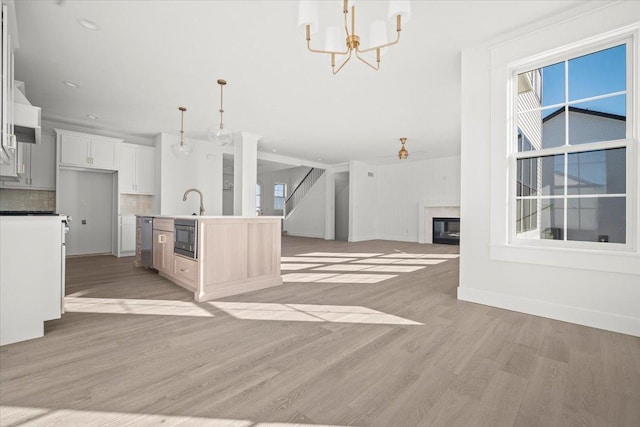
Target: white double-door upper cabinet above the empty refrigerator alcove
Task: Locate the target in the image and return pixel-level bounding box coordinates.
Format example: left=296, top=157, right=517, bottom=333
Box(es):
left=56, top=129, right=122, bottom=170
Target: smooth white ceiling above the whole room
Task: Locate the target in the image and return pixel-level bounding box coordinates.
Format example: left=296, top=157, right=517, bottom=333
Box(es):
left=15, top=0, right=585, bottom=164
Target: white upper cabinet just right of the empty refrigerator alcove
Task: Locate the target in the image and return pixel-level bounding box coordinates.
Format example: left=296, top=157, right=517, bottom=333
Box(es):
left=118, top=143, right=155, bottom=194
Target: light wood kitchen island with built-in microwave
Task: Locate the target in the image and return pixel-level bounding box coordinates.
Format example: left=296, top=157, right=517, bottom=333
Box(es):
left=135, top=215, right=282, bottom=301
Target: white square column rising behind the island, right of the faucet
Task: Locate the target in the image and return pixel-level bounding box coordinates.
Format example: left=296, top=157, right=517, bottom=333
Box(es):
left=233, top=132, right=262, bottom=217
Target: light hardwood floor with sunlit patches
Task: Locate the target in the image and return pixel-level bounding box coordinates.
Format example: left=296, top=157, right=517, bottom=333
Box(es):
left=0, top=237, right=640, bottom=427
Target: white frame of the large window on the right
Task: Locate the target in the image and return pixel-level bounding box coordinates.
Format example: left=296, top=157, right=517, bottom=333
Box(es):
left=506, top=36, right=640, bottom=252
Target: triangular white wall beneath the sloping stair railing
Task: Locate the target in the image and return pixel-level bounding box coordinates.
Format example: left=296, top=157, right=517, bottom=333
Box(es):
left=285, top=174, right=327, bottom=239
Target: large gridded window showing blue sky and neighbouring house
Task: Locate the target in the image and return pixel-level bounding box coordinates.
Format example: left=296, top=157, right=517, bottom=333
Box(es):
left=511, top=41, right=637, bottom=245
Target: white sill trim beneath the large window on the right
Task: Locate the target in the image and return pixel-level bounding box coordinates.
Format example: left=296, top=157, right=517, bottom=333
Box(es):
left=489, top=244, right=640, bottom=275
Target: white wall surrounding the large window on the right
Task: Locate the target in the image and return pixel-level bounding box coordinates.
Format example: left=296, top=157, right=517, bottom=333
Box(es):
left=458, top=2, right=640, bottom=335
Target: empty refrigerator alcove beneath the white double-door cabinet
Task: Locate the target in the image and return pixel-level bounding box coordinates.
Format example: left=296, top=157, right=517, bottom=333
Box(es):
left=57, top=169, right=113, bottom=255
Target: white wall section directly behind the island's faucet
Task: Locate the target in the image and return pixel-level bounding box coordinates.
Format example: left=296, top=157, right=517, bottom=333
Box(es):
left=156, top=133, right=222, bottom=215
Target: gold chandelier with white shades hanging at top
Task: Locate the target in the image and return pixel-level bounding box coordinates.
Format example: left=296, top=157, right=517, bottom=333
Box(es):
left=298, top=0, right=411, bottom=74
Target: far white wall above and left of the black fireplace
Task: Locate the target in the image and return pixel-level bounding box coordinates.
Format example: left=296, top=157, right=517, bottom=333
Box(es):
left=377, top=157, right=460, bottom=242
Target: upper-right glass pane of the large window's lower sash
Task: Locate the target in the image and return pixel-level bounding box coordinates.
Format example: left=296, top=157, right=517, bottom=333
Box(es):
left=567, top=148, right=627, bottom=195
